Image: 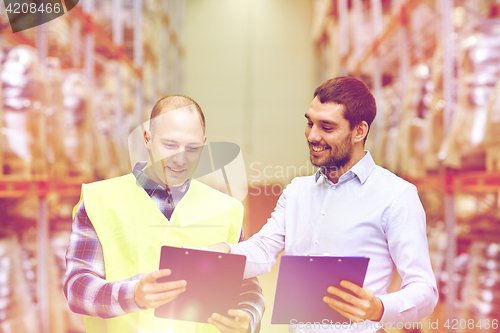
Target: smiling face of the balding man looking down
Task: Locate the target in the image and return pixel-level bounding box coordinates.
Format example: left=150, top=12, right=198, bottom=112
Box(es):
left=144, top=106, right=206, bottom=187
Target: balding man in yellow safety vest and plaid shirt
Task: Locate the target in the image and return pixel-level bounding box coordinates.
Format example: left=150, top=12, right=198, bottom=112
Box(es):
left=64, top=95, right=264, bottom=333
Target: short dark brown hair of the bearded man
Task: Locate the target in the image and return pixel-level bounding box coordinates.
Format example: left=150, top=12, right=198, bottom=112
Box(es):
left=314, top=76, right=377, bottom=141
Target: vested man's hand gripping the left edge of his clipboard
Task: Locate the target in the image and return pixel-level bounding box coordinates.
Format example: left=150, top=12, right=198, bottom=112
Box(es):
left=134, top=269, right=186, bottom=308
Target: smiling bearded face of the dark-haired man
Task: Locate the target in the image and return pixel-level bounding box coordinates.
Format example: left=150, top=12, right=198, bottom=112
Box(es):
left=305, top=97, right=356, bottom=169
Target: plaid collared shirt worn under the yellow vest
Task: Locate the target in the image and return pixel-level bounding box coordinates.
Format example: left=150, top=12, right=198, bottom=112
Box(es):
left=64, top=162, right=265, bottom=332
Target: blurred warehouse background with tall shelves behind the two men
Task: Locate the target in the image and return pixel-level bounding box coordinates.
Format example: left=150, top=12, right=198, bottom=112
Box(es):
left=0, top=0, right=500, bottom=333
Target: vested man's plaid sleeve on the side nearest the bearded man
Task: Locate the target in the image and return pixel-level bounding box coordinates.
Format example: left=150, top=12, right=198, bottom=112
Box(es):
left=238, top=227, right=266, bottom=333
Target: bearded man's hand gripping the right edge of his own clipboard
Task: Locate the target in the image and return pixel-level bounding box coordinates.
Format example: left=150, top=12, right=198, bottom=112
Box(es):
left=323, top=281, right=384, bottom=321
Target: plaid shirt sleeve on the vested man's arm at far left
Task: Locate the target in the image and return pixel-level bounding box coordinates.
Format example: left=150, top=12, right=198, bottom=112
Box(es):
left=64, top=201, right=143, bottom=318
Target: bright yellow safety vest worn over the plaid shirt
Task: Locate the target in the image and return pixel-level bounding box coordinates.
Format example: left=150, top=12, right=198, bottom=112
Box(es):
left=74, top=174, right=243, bottom=333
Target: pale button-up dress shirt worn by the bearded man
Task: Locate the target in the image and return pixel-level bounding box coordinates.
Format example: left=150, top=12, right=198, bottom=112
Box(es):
left=230, top=152, right=438, bottom=332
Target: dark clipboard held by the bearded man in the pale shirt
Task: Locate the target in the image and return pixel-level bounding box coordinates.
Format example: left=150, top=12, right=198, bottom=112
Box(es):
left=271, top=255, right=370, bottom=325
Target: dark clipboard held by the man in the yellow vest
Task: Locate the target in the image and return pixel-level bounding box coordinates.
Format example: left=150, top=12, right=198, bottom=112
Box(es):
left=155, top=246, right=246, bottom=323
